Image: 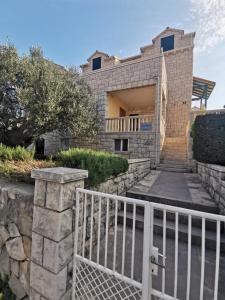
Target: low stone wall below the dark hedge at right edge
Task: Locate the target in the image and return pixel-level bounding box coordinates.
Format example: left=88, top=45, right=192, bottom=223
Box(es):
left=198, top=162, right=225, bottom=215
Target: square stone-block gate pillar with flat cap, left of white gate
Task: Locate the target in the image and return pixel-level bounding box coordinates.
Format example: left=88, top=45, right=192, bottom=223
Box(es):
left=30, top=168, right=88, bottom=300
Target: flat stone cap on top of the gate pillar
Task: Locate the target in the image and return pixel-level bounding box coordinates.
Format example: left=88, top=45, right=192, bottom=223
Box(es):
left=31, top=167, right=88, bottom=183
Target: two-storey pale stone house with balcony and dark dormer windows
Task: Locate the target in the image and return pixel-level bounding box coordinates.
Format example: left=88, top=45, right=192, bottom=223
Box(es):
left=45, top=27, right=215, bottom=166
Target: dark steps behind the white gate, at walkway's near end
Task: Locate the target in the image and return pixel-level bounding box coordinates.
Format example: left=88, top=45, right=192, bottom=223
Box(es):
left=118, top=192, right=225, bottom=251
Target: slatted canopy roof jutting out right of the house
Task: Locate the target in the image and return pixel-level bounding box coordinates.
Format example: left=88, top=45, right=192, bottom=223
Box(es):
left=192, top=77, right=216, bottom=100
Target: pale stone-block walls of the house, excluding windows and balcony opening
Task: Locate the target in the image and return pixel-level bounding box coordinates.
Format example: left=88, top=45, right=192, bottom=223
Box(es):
left=46, top=28, right=195, bottom=165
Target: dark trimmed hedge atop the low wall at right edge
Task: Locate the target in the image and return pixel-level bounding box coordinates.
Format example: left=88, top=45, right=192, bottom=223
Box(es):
left=192, top=113, right=225, bottom=165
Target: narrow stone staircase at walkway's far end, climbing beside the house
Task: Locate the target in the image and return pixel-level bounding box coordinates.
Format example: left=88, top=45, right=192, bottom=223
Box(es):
left=157, top=137, right=190, bottom=173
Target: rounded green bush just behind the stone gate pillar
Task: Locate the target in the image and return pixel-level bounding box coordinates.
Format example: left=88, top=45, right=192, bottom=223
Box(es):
left=56, top=148, right=128, bottom=186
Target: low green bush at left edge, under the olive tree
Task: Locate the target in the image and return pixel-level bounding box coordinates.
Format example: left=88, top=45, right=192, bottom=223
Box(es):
left=0, top=144, right=34, bottom=161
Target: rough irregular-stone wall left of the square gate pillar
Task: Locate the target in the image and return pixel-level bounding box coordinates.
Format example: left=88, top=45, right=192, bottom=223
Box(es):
left=0, top=179, right=34, bottom=300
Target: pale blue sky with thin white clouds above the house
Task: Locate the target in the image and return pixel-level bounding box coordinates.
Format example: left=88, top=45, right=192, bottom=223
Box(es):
left=0, top=0, right=225, bottom=109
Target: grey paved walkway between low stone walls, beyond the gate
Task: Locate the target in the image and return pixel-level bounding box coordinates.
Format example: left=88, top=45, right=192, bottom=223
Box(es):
left=128, top=171, right=217, bottom=212
